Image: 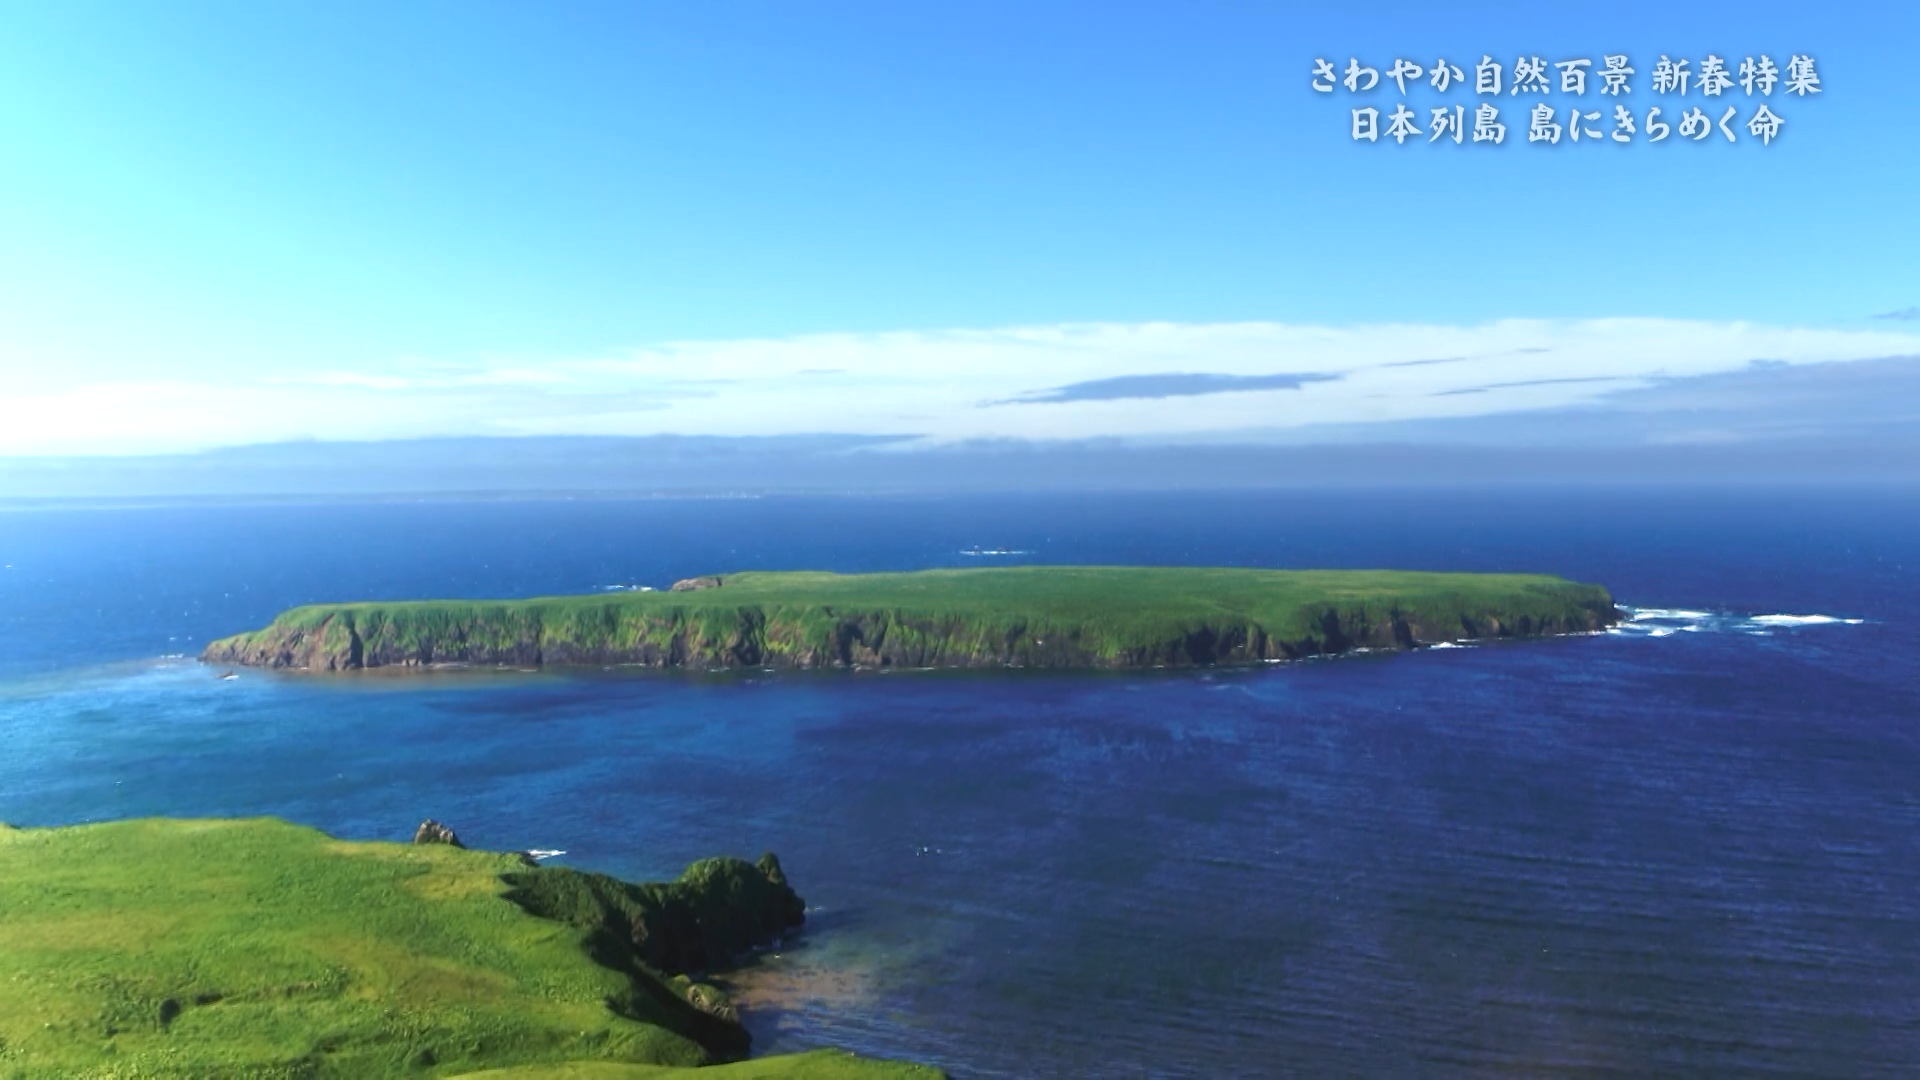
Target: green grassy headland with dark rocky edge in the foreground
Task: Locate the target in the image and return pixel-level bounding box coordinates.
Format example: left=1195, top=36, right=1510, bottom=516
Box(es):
left=0, top=819, right=939, bottom=1080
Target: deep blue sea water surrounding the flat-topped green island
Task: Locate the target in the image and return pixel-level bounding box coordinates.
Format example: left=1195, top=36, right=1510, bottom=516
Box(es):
left=0, top=490, right=1920, bottom=1078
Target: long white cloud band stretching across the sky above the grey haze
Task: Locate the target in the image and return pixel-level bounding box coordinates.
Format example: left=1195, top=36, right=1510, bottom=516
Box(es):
left=0, top=319, right=1920, bottom=454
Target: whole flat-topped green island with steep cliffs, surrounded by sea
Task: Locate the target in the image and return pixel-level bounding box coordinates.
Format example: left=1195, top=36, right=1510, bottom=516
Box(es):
left=204, top=567, right=1619, bottom=671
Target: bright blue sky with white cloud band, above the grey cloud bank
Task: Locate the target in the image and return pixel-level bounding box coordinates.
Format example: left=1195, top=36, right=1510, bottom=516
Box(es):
left=0, top=2, right=1920, bottom=454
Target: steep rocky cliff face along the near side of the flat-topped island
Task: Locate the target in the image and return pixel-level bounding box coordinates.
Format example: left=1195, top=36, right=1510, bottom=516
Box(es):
left=204, top=600, right=1619, bottom=671
